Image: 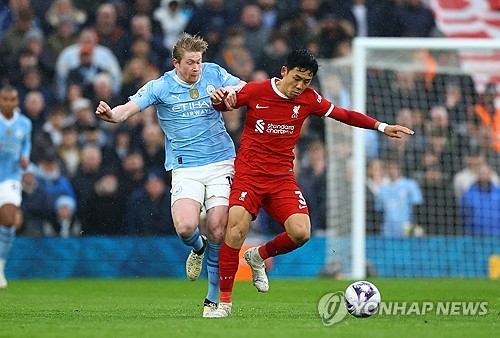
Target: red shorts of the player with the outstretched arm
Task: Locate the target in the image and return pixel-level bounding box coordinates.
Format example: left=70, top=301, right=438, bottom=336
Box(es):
left=229, top=173, right=309, bottom=225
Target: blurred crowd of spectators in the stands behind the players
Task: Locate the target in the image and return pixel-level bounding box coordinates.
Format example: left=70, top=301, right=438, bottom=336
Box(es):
left=0, top=0, right=500, bottom=237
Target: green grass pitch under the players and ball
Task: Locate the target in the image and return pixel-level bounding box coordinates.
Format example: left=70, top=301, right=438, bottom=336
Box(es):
left=0, top=279, right=500, bottom=338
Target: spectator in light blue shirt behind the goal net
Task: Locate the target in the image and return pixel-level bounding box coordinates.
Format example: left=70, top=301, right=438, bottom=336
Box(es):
left=375, top=160, right=423, bottom=237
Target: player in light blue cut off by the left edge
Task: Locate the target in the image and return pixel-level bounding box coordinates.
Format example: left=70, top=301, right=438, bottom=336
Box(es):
left=0, top=86, right=31, bottom=289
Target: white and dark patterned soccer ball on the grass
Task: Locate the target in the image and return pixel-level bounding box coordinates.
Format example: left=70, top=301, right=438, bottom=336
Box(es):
left=344, top=281, right=381, bottom=318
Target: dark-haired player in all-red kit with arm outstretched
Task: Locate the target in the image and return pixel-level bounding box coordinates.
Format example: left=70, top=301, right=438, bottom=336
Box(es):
left=205, top=50, right=413, bottom=318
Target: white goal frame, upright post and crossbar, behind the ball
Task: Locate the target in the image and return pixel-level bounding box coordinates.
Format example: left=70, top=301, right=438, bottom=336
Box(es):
left=350, top=38, right=500, bottom=279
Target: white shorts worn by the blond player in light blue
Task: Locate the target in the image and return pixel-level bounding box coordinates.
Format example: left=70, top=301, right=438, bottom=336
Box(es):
left=172, top=159, right=234, bottom=210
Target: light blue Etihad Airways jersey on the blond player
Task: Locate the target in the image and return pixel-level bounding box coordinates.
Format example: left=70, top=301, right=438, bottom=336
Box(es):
left=129, top=63, right=240, bottom=170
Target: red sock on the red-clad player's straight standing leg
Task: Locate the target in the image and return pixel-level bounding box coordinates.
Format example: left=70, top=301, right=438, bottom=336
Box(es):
left=219, top=242, right=240, bottom=303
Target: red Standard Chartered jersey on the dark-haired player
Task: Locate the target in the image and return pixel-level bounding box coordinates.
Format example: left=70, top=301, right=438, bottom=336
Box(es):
left=235, top=78, right=334, bottom=176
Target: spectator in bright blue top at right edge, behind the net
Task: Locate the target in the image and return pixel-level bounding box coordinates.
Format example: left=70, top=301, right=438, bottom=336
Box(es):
left=460, top=163, right=500, bottom=236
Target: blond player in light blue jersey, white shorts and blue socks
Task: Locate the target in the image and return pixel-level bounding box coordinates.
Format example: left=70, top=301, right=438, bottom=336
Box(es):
left=96, top=34, right=245, bottom=317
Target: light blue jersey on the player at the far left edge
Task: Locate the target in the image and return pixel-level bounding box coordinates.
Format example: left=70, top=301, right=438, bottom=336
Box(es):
left=0, top=109, right=32, bottom=182
